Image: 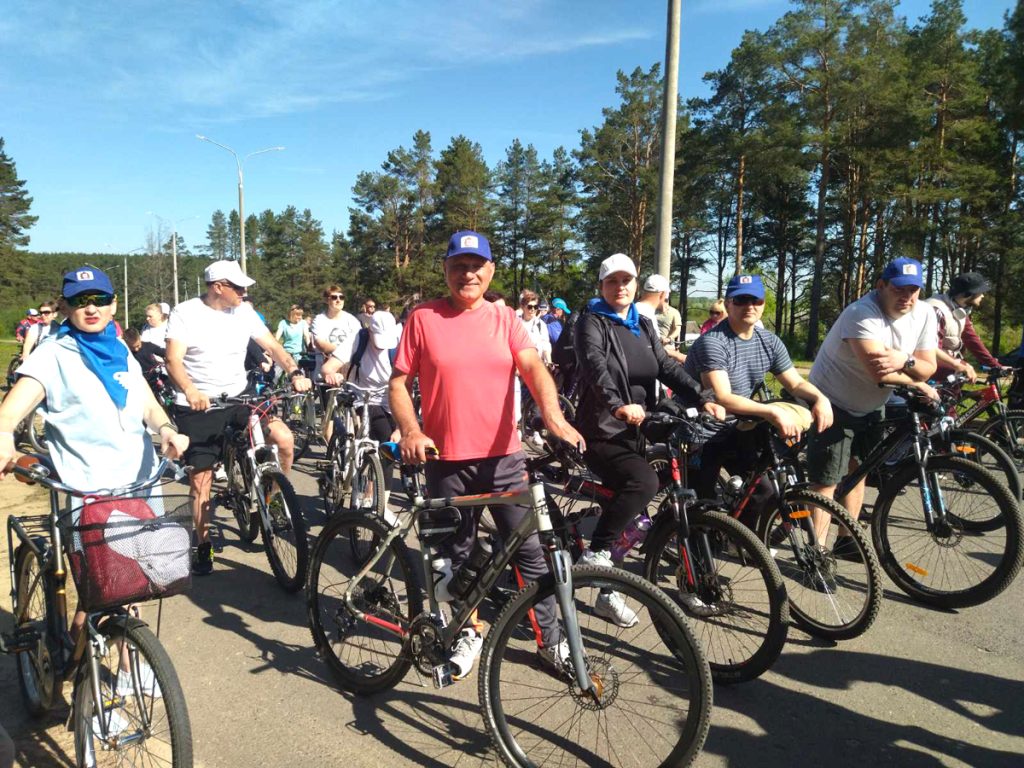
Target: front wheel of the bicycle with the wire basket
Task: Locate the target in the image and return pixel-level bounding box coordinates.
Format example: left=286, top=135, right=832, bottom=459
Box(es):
left=74, top=620, right=193, bottom=768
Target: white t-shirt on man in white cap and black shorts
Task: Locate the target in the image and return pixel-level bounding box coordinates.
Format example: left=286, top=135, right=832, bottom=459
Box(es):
left=167, top=298, right=270, bottom=406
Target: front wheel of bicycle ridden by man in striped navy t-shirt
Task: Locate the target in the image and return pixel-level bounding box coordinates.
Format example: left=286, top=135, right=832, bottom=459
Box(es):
left=758, top=488, right=883, bottom=640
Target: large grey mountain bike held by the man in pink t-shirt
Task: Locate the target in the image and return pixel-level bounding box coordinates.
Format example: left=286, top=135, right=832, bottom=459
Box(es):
left=306, top=443, right=712, bottom=766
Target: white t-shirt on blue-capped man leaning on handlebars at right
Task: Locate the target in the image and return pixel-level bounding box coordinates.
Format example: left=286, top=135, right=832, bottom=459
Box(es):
left=809, top=291, right=938, bottom=416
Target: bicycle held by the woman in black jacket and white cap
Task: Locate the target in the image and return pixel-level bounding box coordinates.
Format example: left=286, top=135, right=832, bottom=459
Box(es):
left=542, top=417, right=790, bottom=684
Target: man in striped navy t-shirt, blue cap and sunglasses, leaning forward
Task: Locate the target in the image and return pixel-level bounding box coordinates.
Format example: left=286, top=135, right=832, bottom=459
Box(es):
left=683, top=274, right=833, bottom=498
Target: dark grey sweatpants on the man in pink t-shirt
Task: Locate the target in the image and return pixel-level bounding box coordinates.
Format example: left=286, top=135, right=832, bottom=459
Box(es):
left=426, top=451, right=561, bottom=646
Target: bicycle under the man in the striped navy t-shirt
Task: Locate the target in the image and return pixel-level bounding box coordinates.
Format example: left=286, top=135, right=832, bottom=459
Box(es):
left=720, top=418, right=883, bottom=641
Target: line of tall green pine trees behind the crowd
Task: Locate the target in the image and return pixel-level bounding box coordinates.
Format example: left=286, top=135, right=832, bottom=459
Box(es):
left=0, top=0, right=1024, bottom=357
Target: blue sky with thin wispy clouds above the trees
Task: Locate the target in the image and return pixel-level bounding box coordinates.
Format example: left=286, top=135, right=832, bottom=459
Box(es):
left=0, top=0, right=1013, bottom=259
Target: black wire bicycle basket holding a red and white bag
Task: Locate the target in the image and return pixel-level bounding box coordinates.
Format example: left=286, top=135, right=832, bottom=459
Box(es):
left=62, top=496, right=193, bottom=610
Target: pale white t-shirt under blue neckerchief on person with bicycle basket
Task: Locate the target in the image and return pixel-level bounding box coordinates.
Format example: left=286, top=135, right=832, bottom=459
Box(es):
left=17, top=336, right=157, bottom=490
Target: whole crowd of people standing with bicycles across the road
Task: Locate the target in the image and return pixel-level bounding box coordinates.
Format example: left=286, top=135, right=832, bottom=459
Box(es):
left=0, top=230, right=1011, bottom=765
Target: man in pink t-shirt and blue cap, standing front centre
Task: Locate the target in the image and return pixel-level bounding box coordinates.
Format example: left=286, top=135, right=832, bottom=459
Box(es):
left=389, top=230, right=583, bottom=679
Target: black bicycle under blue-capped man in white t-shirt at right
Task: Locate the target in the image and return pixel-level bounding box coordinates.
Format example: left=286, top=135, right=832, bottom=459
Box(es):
left=836, top=385, right=1024, bottom=608
